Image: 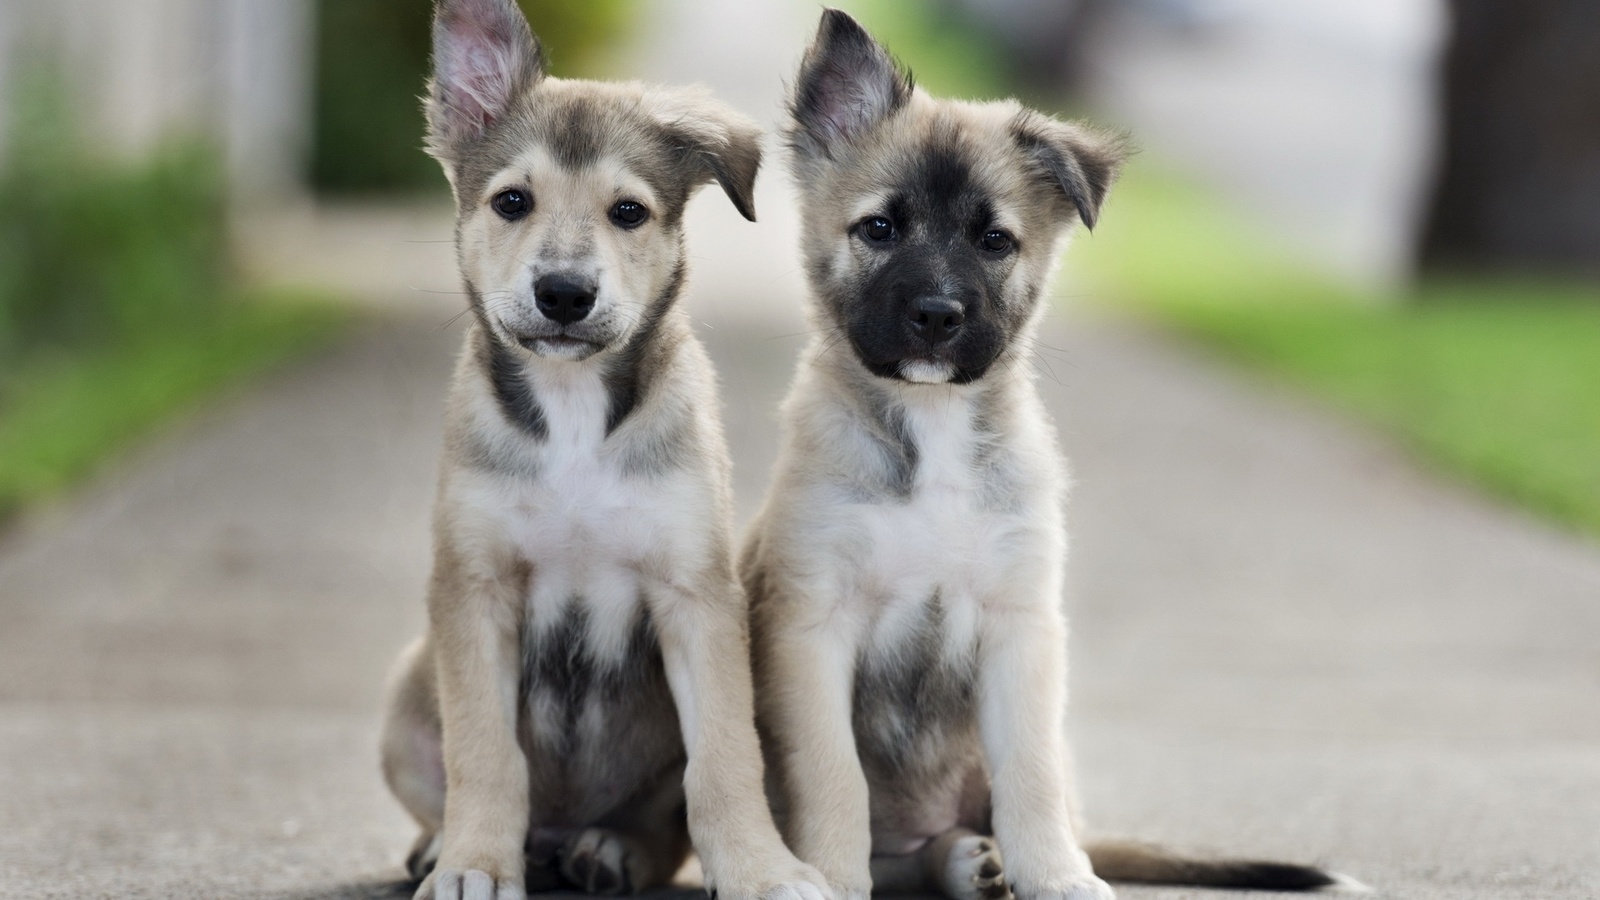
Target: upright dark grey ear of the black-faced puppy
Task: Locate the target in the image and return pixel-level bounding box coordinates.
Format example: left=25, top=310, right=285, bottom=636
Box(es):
left=789, top=10, right=912, bottom=157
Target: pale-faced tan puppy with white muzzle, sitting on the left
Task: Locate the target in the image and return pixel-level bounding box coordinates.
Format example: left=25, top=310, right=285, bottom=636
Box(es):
left=382, top=0, right=826, bottom=900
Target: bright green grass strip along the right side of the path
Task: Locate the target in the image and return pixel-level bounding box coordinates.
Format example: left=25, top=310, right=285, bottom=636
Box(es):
left=1074, top=165, right=1600, bottom=535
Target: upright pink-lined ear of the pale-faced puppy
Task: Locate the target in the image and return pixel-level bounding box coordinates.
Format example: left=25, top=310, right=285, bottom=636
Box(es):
left=427, top=0, right=544, bottom=157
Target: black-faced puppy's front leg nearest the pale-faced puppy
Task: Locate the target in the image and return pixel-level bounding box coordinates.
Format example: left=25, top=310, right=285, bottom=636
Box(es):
left=757, top=602, right=872, bottom=900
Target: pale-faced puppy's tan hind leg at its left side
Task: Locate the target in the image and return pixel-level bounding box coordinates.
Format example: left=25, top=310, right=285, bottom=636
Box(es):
left=379, top=637, right=445, bottom=881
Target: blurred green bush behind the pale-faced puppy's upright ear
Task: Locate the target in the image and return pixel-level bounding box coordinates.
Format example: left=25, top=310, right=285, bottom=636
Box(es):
left=310, top=0, right=637, bottom=192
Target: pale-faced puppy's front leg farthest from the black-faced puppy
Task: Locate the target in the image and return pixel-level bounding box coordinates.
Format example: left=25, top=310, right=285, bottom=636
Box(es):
left=416, top=564, right=528, bottom=900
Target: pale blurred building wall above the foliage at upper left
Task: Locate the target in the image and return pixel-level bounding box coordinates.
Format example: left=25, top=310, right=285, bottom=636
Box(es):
left=0, top=0, right=314, bottom=192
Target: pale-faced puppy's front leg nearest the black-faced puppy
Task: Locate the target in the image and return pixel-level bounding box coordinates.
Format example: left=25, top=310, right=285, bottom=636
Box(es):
left=658, top=578, right=829, bottom=900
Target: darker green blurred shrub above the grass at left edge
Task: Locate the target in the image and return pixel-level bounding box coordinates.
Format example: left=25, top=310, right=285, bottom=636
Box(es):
left=0, top=75, right=226, bottom=358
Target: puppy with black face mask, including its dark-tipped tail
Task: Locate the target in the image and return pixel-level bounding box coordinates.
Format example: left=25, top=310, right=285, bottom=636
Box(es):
left=741, top=11, right=1363, bottom=900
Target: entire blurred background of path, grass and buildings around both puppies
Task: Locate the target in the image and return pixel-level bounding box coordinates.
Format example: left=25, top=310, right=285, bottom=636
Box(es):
left=0, top=0, right=1600, bottom=898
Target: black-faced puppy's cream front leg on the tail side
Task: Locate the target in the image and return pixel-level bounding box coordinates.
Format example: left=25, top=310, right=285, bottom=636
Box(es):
left=978, top=604, right=1112, bottom=900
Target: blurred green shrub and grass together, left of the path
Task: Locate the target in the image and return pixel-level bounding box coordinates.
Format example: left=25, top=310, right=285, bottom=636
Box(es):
left=0, top=66, right=344, bottom=520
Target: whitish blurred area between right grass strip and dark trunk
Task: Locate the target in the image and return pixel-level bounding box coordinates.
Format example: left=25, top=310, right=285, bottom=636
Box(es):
left=1086, top=0, right=1450, bottom=283
